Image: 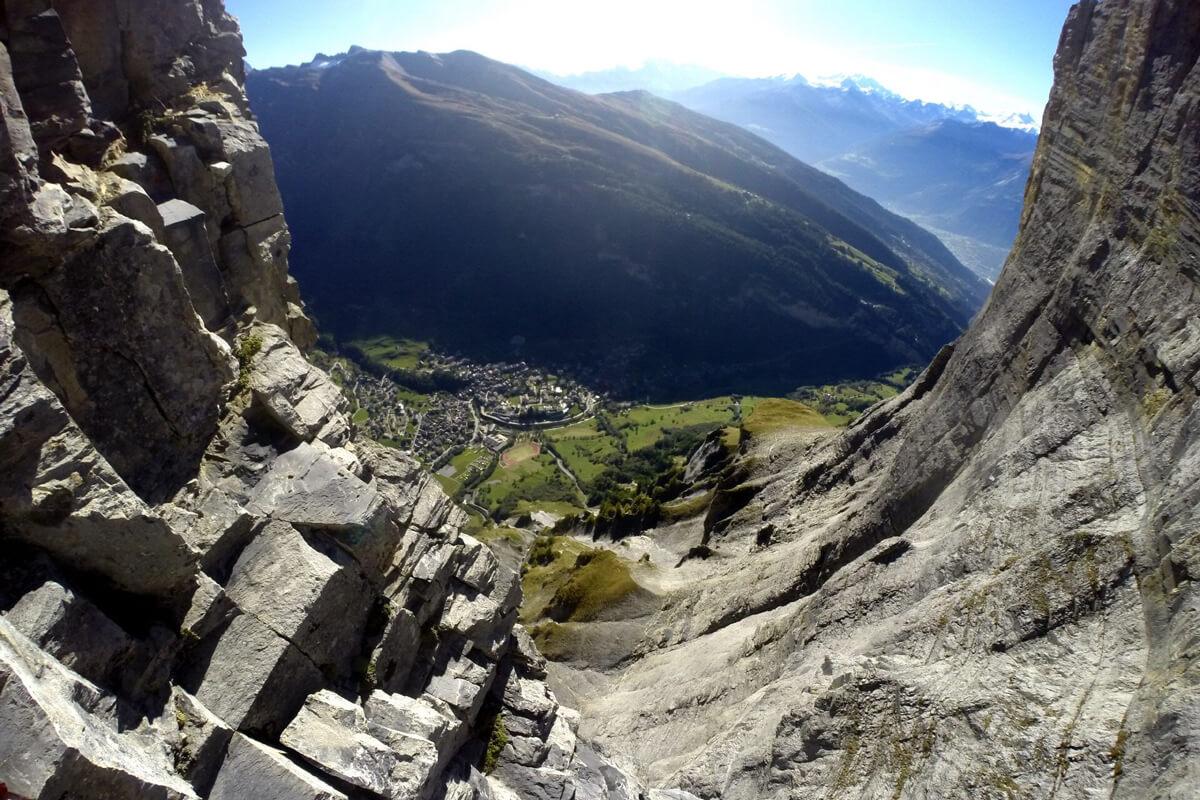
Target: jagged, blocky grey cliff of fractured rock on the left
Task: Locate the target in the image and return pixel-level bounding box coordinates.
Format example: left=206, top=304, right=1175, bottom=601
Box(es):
left=0, top=0, right=684, bottom=800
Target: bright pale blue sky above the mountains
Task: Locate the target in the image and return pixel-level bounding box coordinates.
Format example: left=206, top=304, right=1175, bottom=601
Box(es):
left=226, top=0, right=1072, bottom=114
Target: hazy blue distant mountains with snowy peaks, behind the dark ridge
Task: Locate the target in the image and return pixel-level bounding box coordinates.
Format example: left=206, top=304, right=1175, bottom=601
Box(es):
left=540, top=62, right=1037, bottom=279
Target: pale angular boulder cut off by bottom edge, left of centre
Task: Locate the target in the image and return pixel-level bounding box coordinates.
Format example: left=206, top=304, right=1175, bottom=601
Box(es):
left=209, top=733, right=346, bottom=800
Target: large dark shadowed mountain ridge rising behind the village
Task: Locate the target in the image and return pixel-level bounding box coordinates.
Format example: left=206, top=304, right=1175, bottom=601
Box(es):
left=247, top=50, right=988, bottom=398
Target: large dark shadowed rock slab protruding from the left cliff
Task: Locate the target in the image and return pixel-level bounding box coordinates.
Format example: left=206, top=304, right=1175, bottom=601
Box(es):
left=12, top=215, right=233, bottom=500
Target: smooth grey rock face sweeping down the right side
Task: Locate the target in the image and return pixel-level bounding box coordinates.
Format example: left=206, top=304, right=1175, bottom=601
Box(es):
left=553, top=0, right=1200, bottom=800
